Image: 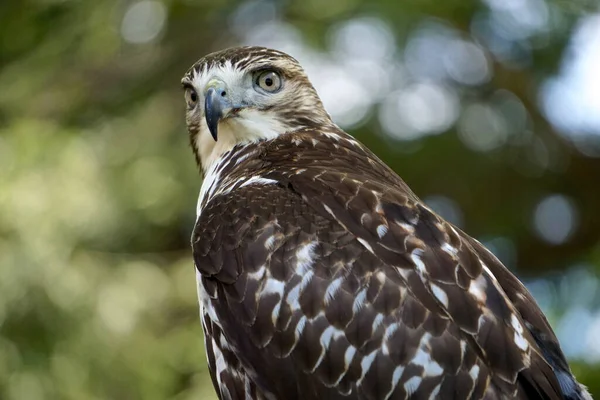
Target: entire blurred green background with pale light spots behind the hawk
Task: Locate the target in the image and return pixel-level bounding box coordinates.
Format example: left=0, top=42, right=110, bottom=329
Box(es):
left=0, top=0, right=600, bottom=400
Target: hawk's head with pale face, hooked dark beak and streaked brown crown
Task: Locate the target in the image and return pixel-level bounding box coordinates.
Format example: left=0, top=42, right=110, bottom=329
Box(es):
left=181, top=47, right=332, bottom=170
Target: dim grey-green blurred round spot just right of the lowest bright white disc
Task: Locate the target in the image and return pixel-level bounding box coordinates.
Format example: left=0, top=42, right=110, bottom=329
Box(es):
left=458, top=103, right=508, bottom=151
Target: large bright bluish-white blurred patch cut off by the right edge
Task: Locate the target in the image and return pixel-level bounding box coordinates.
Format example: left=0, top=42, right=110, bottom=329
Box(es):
left=540, top=14, right=600, bottom=150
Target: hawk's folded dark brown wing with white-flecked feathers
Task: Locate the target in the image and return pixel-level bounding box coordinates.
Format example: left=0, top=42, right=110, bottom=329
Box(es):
left=193, top=133, right=571, bottom=399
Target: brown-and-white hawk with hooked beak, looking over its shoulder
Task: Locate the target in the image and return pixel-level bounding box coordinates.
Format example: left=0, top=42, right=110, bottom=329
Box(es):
left=182, top=47, right=591, bottom=400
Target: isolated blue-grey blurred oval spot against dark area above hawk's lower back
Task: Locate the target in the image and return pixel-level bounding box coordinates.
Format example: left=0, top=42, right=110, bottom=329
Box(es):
left=533, top=194, right=577, bottom=245
